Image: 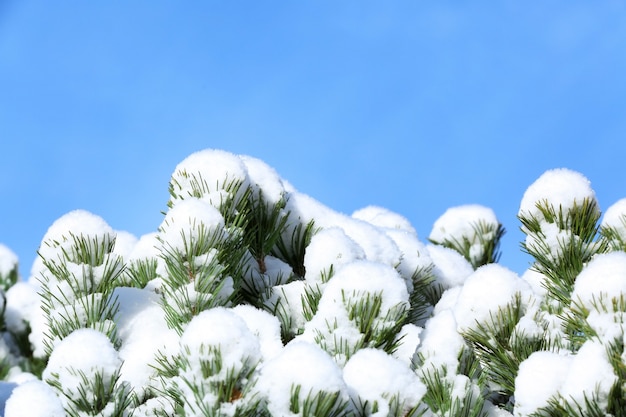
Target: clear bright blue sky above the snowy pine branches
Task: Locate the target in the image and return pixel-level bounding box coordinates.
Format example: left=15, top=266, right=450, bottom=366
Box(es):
left=0, top=0, right=626, bottom=277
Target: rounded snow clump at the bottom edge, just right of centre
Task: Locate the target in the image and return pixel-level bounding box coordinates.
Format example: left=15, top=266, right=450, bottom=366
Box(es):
left=343, top=349, right=426, bottom=417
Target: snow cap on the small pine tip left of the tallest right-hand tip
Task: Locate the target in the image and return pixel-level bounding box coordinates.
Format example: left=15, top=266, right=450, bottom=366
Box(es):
left=428, top=204, right=500, bottom=244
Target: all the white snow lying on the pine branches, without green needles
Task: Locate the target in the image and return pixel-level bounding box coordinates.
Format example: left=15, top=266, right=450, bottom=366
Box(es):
left=0, top=154, right=626, bottom=417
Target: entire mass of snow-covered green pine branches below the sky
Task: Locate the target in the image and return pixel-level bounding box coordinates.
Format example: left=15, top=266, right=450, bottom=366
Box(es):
left=0, top=150, right=626, bottom=417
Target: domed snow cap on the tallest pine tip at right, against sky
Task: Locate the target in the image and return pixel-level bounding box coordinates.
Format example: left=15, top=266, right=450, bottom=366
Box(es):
left=518, top=168, right=597, bottom=219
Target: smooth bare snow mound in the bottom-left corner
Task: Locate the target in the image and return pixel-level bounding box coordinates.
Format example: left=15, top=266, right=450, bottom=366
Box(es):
left=4, top=380, right=66, bottom=417
